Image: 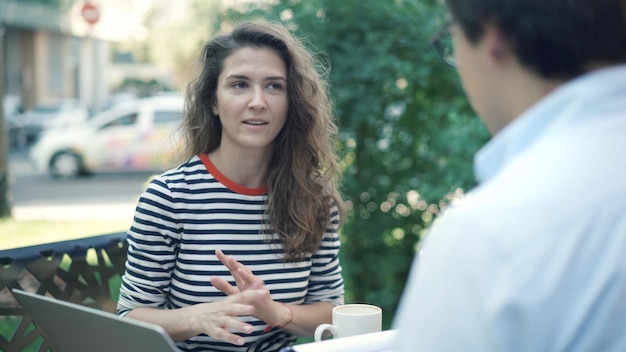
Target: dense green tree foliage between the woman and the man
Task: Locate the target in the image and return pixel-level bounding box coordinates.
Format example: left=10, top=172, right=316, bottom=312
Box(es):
left=221, top=0, right=487, bottom=327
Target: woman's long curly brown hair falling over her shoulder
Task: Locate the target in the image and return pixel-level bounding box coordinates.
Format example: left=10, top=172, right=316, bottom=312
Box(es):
left=183, top=23, right=343, bottom=261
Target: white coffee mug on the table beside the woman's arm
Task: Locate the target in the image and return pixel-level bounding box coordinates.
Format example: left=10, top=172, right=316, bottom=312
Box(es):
left=315, top=304, right=383, bottom=342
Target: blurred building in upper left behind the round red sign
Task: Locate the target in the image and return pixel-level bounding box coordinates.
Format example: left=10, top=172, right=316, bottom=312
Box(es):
left=0, top=0, right=151, bottom=112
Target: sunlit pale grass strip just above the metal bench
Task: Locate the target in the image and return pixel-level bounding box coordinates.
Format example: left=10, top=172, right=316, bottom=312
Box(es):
left=0, top=218, right=130, bottom=250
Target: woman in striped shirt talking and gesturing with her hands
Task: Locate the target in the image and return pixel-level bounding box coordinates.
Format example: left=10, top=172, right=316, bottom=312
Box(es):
left=118, top=23, right=344, bottom=351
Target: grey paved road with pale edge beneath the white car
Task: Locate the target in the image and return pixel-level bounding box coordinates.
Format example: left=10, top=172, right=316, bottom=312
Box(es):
left=9, top=151, right=155, bottom=219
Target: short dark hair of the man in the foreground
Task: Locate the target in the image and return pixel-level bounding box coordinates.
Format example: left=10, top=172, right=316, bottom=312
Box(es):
left=446, top=0, right=626, bottom=79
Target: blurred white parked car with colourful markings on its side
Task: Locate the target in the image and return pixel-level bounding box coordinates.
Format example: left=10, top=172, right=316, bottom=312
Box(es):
left=30, top=96, right=184, bottom=178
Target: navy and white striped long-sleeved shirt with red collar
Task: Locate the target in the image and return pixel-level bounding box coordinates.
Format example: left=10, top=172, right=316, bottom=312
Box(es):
left=118, top=154, right=344, bottom=351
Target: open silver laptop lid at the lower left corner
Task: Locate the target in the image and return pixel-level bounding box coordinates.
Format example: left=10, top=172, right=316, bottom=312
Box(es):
left=12, top=289, right=179, bottom=352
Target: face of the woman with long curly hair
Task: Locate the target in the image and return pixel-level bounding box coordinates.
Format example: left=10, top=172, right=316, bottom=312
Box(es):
left=213, top=47, right=288, bottom=153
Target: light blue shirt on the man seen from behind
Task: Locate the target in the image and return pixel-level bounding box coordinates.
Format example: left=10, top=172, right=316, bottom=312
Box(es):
left=394, top=65, right=626, bottom=352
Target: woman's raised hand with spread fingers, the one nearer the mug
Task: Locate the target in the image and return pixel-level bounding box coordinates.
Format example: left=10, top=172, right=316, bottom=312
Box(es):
left=211, top=249, right=292, bottom=326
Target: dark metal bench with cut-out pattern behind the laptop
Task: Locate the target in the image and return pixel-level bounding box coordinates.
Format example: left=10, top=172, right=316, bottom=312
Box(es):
left=0, top=233, right=128, bottom=352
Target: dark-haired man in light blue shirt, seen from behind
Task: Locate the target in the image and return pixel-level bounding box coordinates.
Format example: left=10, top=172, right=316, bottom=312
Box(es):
left=394, top=0, right=626, bottom=352
